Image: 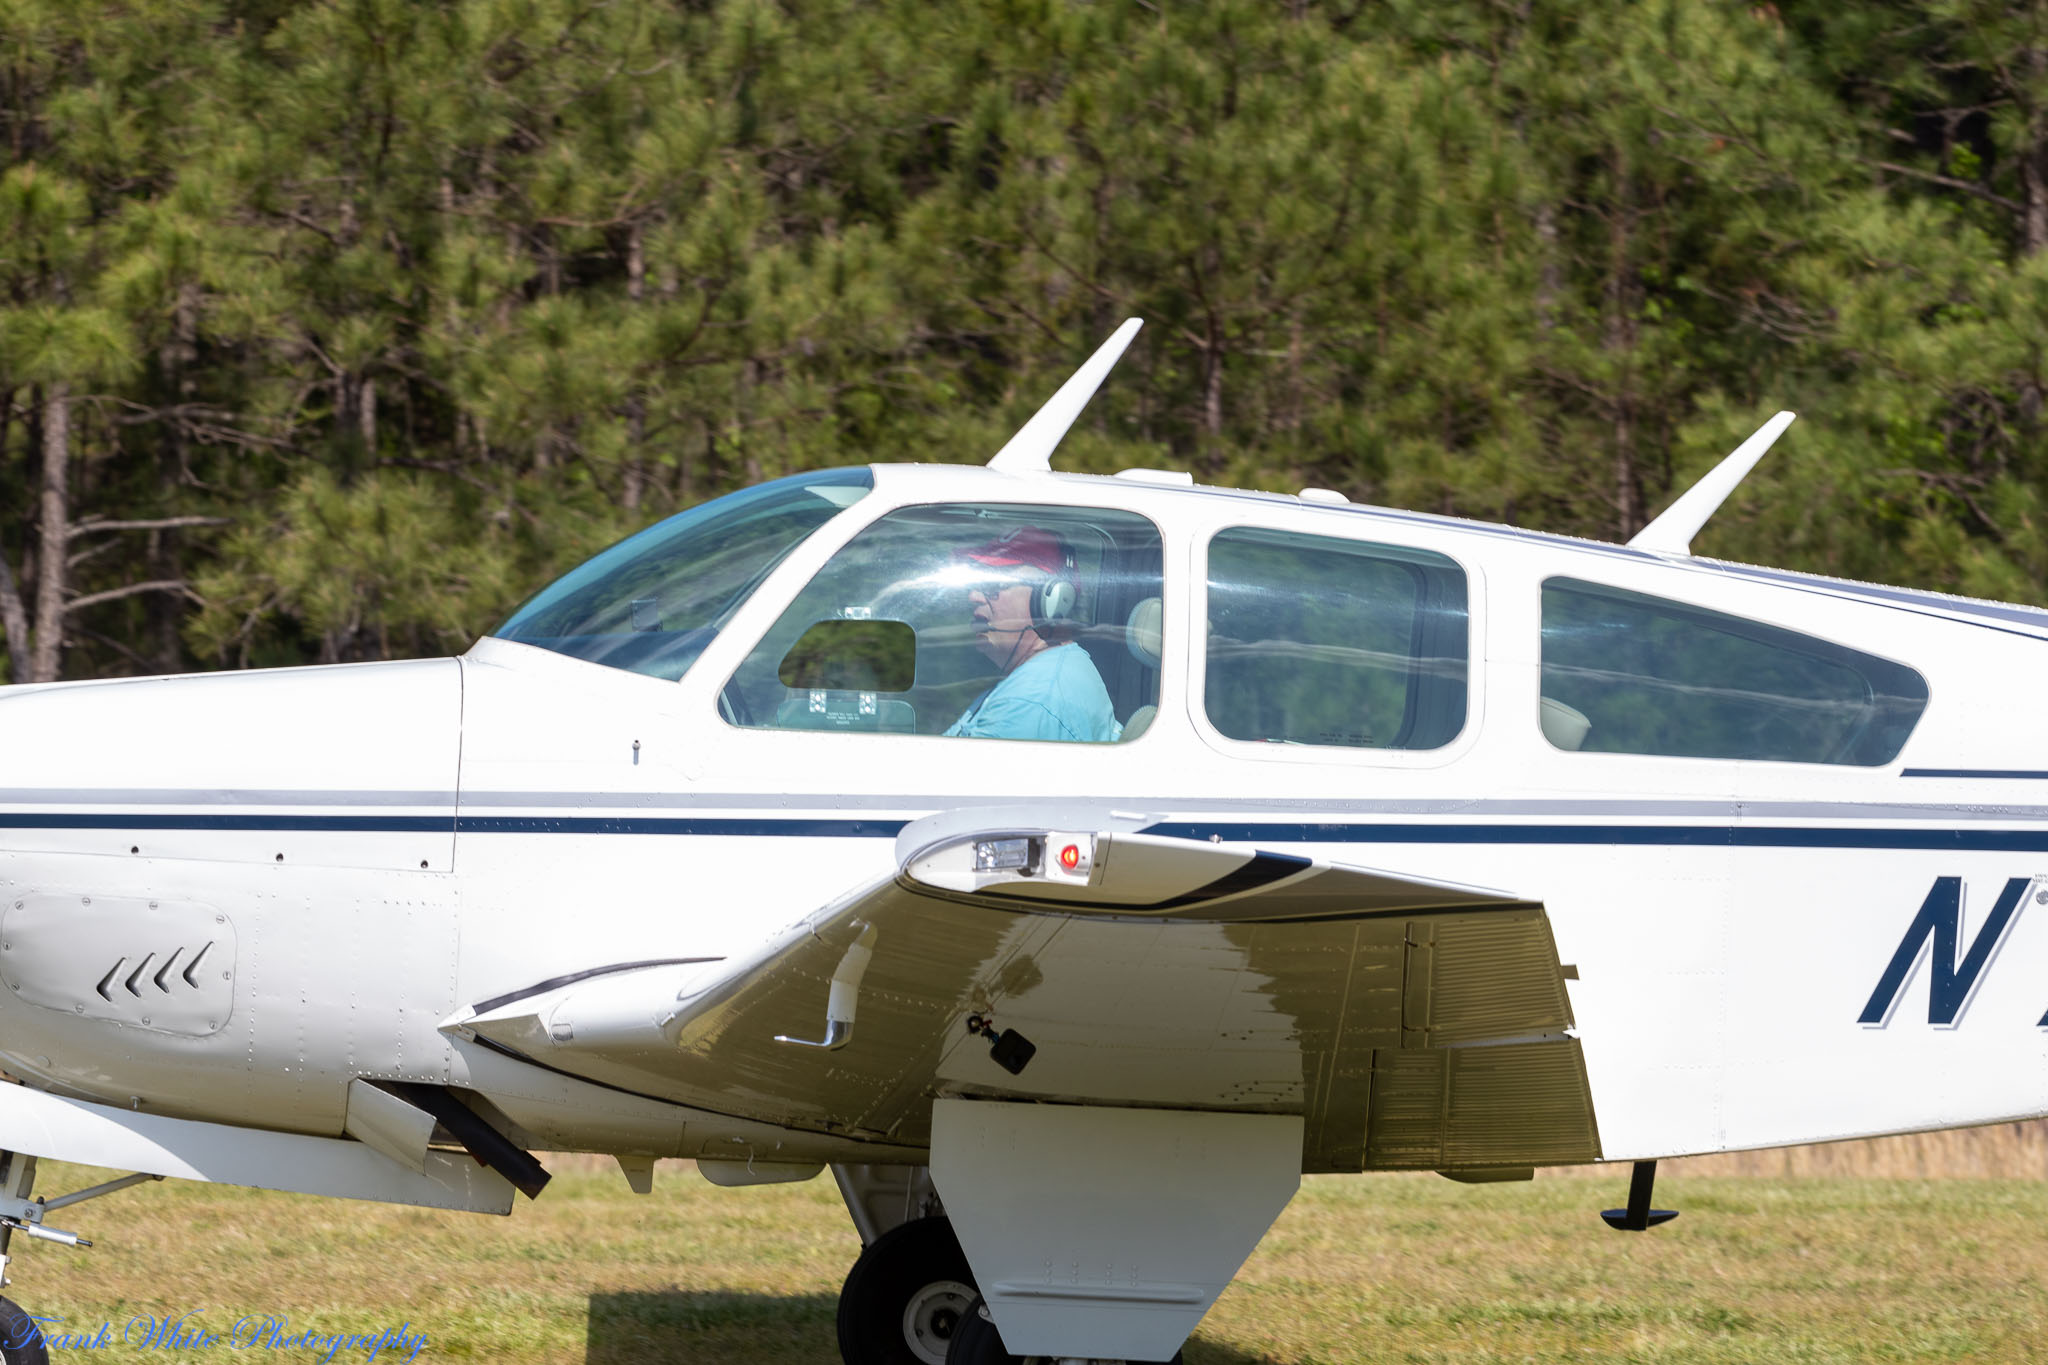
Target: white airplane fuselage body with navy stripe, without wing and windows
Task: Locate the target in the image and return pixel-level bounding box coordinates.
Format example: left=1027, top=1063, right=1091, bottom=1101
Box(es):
left=0, top=469, right=2048, bottom=1160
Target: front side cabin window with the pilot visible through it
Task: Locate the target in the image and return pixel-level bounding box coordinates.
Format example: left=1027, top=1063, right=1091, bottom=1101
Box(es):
left=721, top=503, right=1163, bottom=743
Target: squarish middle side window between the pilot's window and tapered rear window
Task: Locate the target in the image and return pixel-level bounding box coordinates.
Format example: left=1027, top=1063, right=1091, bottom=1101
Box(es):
left=1204, top=526, right=1468, bottom=749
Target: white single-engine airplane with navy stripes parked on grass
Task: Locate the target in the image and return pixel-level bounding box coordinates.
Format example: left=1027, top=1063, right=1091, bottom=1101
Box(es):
left=0, top=319, right=2048, bottom=1365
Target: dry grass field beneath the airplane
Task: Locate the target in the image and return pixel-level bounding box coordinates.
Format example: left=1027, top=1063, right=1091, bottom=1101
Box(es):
left=8, top=1158, right=2048, bottom=1365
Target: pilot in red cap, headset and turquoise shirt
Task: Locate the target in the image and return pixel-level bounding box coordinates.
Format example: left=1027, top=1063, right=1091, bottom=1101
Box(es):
left=946, top=526, right=1122, bottom=743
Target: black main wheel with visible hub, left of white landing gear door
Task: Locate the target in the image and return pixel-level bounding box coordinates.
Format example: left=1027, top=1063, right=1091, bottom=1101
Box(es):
left=840, top=1218, right=981, bottom=1365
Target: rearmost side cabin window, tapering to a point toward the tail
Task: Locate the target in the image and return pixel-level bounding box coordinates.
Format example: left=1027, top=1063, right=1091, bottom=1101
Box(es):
left=1540, top=577, right=1927, bottom=767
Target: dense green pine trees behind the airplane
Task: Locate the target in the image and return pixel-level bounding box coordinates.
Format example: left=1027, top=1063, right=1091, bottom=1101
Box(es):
left=0, top=0, right=2048, bottom=673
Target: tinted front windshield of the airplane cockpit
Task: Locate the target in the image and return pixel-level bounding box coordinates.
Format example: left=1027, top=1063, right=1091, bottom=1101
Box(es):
left=494, top=469, right=874, bottom=679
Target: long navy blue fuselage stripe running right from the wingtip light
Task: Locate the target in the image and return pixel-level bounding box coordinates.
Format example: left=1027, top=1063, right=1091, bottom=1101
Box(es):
left=1139, top=821, right=2048, bottom=853
